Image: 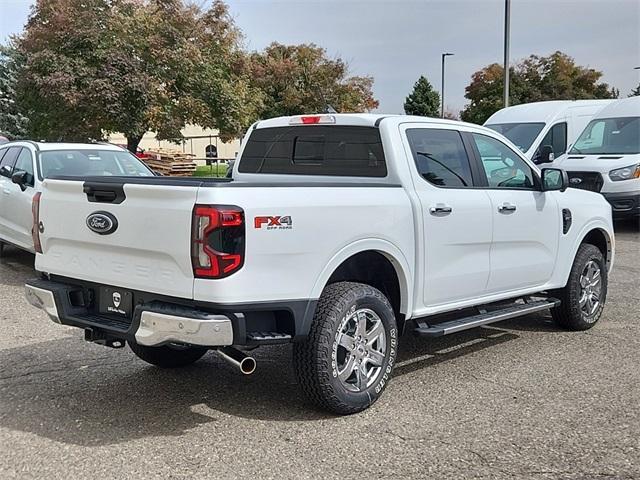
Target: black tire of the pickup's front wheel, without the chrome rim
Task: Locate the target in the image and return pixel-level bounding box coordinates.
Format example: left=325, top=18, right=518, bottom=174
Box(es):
left=550, top=243, right=608, bottom=330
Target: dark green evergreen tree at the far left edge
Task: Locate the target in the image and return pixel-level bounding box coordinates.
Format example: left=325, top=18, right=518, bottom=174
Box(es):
left=0, top=42, right=27, bottom=139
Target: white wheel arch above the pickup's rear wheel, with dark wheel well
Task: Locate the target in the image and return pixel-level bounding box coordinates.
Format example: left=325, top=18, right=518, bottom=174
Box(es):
left=310, top=239, right=412, bottom=321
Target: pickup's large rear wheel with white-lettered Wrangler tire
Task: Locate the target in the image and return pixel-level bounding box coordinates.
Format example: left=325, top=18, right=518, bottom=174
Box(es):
left=293, top=282, right=398, bottom=415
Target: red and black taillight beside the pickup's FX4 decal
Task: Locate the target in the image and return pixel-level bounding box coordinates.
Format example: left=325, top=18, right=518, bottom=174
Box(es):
left=191, top=205, right=245, bottom=278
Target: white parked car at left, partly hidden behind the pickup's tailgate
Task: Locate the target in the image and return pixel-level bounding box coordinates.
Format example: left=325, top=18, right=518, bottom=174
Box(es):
left=0, top=141, right=153, bottom=252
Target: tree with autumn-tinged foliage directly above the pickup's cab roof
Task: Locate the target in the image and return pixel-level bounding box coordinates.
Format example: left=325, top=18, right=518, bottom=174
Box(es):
left=246, top=43, right=378, bottom=118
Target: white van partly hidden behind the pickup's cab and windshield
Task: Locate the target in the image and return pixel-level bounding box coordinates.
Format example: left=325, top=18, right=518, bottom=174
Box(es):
left=484, top=100, right=614, bottom=163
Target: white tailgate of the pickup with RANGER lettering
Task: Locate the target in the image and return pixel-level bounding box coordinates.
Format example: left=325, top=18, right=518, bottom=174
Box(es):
left=36, top=180, right=198, bottom=298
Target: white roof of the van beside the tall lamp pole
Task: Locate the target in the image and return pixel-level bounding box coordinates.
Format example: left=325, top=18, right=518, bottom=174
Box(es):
left=484, top=100, right=611, bottom=125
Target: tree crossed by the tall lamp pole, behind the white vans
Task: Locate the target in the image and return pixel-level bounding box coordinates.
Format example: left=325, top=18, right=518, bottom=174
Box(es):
left=460, top=52, right=619, bottom=124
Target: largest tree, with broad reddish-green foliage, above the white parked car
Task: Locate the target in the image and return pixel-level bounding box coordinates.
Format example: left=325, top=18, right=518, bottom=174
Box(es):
left=11, top=0, right=260, bottom=151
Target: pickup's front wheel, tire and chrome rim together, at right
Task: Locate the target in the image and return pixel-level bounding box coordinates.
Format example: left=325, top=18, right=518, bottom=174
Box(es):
left=551, top=243, right=608, bottom=330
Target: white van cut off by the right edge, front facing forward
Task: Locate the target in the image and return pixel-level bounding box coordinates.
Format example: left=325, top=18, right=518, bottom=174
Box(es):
left=553, top=97, right=640, bottom=218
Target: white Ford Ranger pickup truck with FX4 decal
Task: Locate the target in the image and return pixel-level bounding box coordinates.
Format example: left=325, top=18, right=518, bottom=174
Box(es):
left=26, top=115, right=614, bottom=414
